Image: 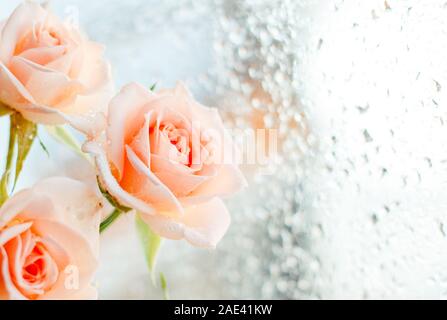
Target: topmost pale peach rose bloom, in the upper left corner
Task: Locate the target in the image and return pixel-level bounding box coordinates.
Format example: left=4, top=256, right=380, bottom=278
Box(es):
left=0, top=1, right=113, bottom=130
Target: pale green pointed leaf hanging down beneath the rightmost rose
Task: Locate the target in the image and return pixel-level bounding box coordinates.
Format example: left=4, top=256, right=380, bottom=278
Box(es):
left=136, top=212, right=161, bottom=286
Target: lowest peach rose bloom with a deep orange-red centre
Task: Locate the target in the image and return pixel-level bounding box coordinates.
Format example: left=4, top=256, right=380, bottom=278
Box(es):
left=0, top=178, right=101, bottom=300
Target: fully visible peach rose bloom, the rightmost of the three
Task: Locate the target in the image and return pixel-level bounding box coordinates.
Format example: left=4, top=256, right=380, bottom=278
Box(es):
left=84, top=83, right=246, bottom=247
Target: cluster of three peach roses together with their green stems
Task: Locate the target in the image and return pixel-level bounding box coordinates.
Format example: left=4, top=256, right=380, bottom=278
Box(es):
left=0, top=2, right=245, bottom=299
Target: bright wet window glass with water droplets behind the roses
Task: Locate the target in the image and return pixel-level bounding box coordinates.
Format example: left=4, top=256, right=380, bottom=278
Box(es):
left=0, top=0, right=447, bottom=299
